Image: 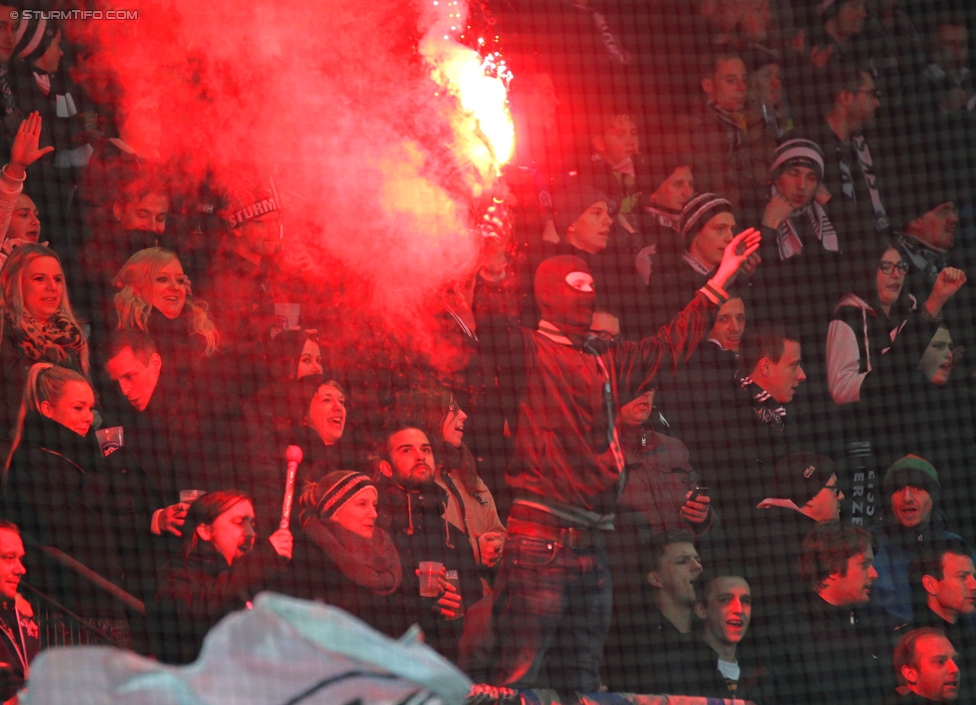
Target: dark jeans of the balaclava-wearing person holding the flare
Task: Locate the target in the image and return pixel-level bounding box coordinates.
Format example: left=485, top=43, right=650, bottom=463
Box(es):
left=491, top=529, right=613, bottom=692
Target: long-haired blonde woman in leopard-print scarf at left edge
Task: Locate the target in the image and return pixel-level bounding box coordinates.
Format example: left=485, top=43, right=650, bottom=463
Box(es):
left=0, top=244, right=90, bottom=458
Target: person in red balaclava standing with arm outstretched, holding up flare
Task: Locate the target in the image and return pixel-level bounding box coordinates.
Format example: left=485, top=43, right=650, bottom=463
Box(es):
left=478, top=230, right=759, bottom=691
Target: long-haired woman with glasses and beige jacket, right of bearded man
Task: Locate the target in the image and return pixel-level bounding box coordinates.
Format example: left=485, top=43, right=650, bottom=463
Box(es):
left=396, top=385, right=505, bottom=568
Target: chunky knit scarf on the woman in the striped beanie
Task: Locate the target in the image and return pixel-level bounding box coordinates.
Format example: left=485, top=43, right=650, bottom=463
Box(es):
left=304, top=517, right=403, bottom=595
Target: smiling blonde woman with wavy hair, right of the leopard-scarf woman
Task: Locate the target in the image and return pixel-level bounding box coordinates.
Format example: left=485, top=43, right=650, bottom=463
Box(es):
left=114, top=247, right=220, bottom=368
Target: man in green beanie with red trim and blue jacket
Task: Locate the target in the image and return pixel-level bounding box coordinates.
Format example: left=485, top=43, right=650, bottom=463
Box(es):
left=870, top=455, right=960, bottom=622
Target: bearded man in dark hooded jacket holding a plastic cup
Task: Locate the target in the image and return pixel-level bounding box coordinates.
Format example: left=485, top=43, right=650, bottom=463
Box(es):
left=376, top=421, right=482, bottom=663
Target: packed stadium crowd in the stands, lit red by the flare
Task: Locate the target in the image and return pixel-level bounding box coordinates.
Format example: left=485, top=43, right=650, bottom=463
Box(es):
left=0, top=0, right=976, bottom=705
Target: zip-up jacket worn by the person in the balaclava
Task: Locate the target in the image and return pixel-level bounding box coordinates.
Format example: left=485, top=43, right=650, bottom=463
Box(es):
left=478, top=286, right=716, bottom=515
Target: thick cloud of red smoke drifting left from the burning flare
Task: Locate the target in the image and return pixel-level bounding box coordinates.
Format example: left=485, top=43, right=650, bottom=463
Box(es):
left=66, top=0, right=492, bottom=372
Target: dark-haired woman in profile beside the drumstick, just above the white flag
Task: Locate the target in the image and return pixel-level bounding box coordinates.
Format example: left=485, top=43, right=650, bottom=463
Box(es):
left=151, top=490, right=293, bottom=663
